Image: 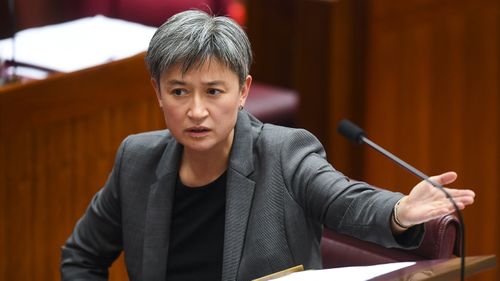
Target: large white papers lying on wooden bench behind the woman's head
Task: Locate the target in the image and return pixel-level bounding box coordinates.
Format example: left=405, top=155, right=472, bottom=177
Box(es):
left=0, top=15, right=156, bottom=72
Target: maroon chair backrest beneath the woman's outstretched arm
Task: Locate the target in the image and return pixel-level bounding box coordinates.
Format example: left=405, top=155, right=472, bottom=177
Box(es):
left=321, top=214, right=461, bottom=268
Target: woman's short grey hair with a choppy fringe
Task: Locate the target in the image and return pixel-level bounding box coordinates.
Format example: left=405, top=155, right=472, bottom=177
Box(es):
left=146, top=10, right=252, bottom=86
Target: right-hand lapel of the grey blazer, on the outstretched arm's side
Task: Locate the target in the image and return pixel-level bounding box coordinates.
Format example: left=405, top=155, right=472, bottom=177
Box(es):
left=222, top=112, right=255, bottom=280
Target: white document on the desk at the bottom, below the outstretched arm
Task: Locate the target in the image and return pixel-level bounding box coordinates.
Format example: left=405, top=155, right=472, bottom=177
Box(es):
left=274, top=262, right=415, bottom=281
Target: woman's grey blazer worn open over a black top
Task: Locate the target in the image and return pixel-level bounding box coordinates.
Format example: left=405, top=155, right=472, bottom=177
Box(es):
left=61, top=110, right=423, bottom=281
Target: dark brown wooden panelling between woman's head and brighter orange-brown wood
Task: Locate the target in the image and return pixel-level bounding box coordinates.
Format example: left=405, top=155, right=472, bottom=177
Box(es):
left=248, top=0, right=365, bottom=177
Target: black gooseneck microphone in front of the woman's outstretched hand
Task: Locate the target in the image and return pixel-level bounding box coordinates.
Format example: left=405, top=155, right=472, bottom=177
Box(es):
left=337, top=119, right=465, bottom=281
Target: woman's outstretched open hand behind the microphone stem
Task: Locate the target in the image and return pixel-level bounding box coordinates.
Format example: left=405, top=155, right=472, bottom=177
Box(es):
left=393, top=172, right=475, bottom=232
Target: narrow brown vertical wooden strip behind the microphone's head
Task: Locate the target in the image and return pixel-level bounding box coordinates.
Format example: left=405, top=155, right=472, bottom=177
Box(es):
left=326, top=0, right=367, bottom=175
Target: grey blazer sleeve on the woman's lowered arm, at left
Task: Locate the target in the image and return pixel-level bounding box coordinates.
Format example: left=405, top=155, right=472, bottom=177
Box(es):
left=61, top=137, right=126, bottom=280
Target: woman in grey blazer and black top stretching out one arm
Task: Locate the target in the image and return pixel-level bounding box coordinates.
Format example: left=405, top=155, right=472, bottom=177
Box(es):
left=62, top=8, right=474, bottom=280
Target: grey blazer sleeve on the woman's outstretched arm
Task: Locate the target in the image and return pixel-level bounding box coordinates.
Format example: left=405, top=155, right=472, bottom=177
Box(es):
left=280, top=130, right=424, bottom=248
